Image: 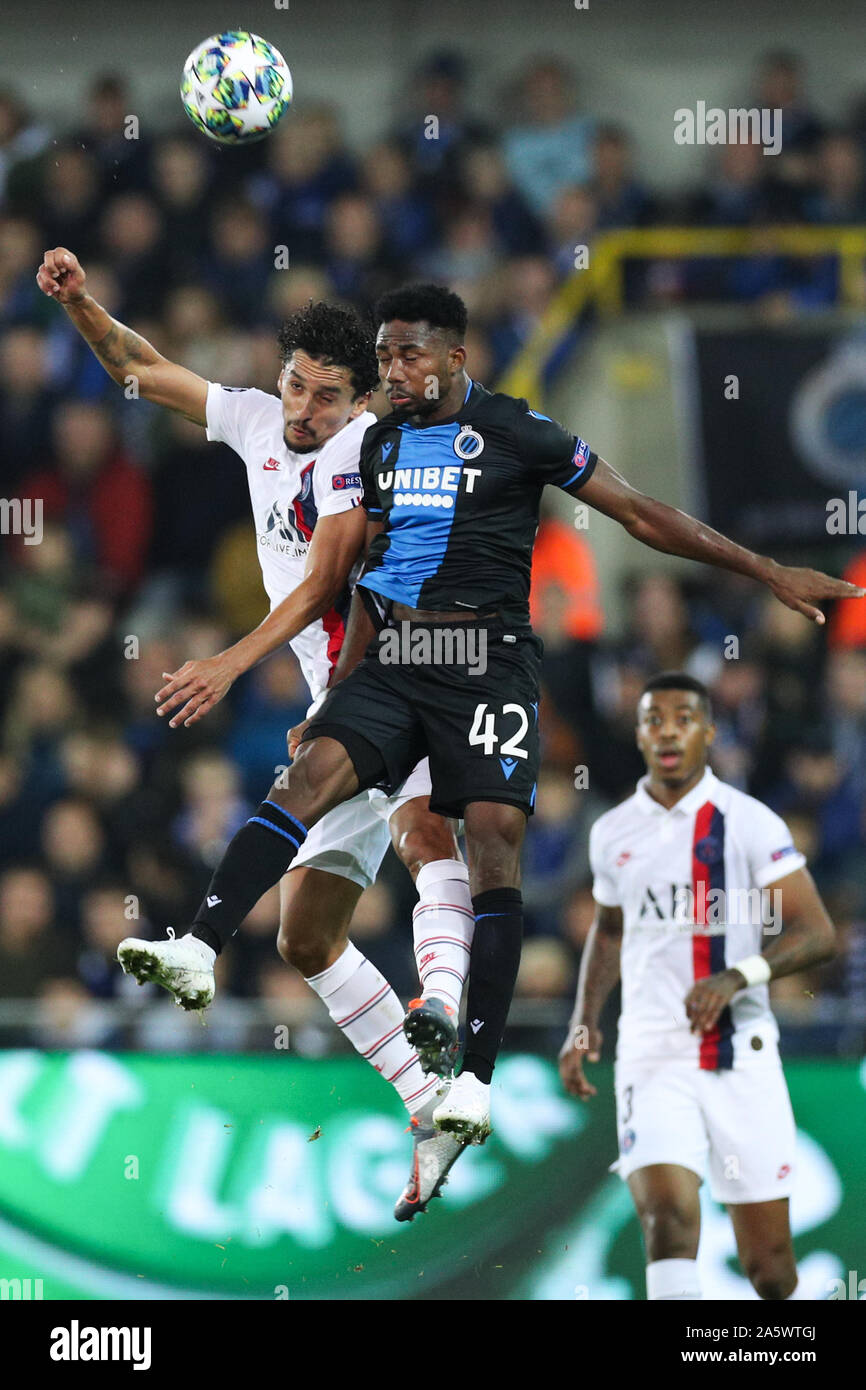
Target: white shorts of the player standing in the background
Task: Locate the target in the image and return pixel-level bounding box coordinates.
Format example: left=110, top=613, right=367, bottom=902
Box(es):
left=612, top=1048, right=796, bottom=1204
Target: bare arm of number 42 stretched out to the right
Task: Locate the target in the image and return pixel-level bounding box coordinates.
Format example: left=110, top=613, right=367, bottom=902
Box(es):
left=575, top=459, right=866, bottom=623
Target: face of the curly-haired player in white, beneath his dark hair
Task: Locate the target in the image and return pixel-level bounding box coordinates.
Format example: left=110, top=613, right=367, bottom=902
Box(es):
left=277, top=348, right=370, bottom=453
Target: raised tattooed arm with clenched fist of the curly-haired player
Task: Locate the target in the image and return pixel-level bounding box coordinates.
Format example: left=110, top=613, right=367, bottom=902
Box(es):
left=36, top=246, right=207, bottom=425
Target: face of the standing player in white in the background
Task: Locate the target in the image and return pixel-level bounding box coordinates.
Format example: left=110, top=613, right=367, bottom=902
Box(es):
left=637, top=691, right=716, bottom=791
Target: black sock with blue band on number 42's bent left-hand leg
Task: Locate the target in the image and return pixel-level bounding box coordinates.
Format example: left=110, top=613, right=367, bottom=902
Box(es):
left=192, top=801, right=307, bottom=955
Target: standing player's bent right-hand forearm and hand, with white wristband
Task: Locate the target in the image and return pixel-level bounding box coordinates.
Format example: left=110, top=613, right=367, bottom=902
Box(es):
left=685, top=869, right=835, bottom=1033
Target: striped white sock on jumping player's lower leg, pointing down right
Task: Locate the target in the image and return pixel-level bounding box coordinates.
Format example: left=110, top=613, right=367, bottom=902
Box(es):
left=307, top=942, right=439, bottom=1115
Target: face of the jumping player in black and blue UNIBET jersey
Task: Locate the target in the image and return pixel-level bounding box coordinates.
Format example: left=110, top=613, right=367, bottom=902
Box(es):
left=375, top=318, right=466, bottom=418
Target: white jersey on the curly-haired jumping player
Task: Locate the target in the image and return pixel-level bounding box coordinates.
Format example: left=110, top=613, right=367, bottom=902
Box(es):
left=207, top=381, right=375, bottom=698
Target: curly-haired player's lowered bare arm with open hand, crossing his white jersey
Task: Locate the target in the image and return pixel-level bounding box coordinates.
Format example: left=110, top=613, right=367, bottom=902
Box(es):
left=156, top=507, right=364, bottom=728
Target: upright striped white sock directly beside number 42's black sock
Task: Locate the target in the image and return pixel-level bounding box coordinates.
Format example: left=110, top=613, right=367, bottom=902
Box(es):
left=413, top=859, right=475, bottom=1012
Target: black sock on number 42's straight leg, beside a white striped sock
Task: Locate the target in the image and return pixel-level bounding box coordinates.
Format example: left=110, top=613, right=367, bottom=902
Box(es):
left=461, top=888, right=523, bottom=1086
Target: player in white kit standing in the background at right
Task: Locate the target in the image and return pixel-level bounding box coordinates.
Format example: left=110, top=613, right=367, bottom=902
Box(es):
left=559, top=671, right=834, bottom=1301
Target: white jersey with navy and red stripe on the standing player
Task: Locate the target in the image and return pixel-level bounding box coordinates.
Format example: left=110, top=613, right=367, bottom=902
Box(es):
left=589, top=769, right=806, bottom=1070
